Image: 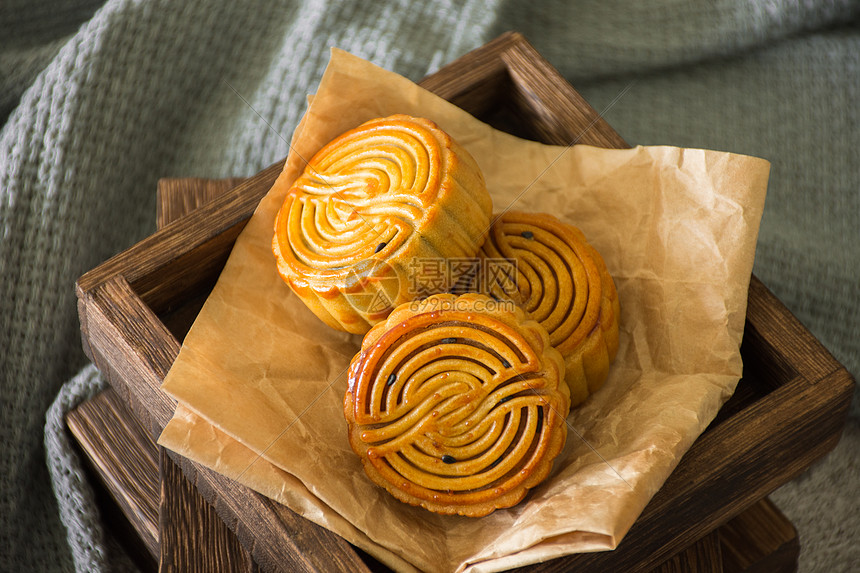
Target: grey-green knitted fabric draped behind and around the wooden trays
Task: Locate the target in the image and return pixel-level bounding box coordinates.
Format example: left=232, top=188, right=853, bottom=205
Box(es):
left=0, top=0, right=860, bottom=571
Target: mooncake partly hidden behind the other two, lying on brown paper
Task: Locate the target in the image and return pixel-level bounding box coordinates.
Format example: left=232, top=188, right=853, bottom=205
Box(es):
left=477, top=211, right=621, bottom=406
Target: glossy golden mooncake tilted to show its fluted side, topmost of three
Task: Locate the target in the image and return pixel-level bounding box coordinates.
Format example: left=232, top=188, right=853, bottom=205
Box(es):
left=272, top=115, right=492, bottom=334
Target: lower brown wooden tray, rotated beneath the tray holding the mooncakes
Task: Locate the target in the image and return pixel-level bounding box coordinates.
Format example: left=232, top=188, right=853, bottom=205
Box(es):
left=72, top=174, right=799, bottom=573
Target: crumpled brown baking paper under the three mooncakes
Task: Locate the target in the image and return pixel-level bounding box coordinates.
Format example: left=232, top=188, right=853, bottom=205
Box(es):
left=159, top=50, right=769, bottom=572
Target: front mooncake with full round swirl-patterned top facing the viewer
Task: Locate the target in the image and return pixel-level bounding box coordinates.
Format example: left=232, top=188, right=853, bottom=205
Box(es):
left=344, top=293, right=570, bottom=517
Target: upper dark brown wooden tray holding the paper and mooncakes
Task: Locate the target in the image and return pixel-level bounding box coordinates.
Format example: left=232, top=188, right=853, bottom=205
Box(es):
left=72, top=34, right=853, bottom=571
